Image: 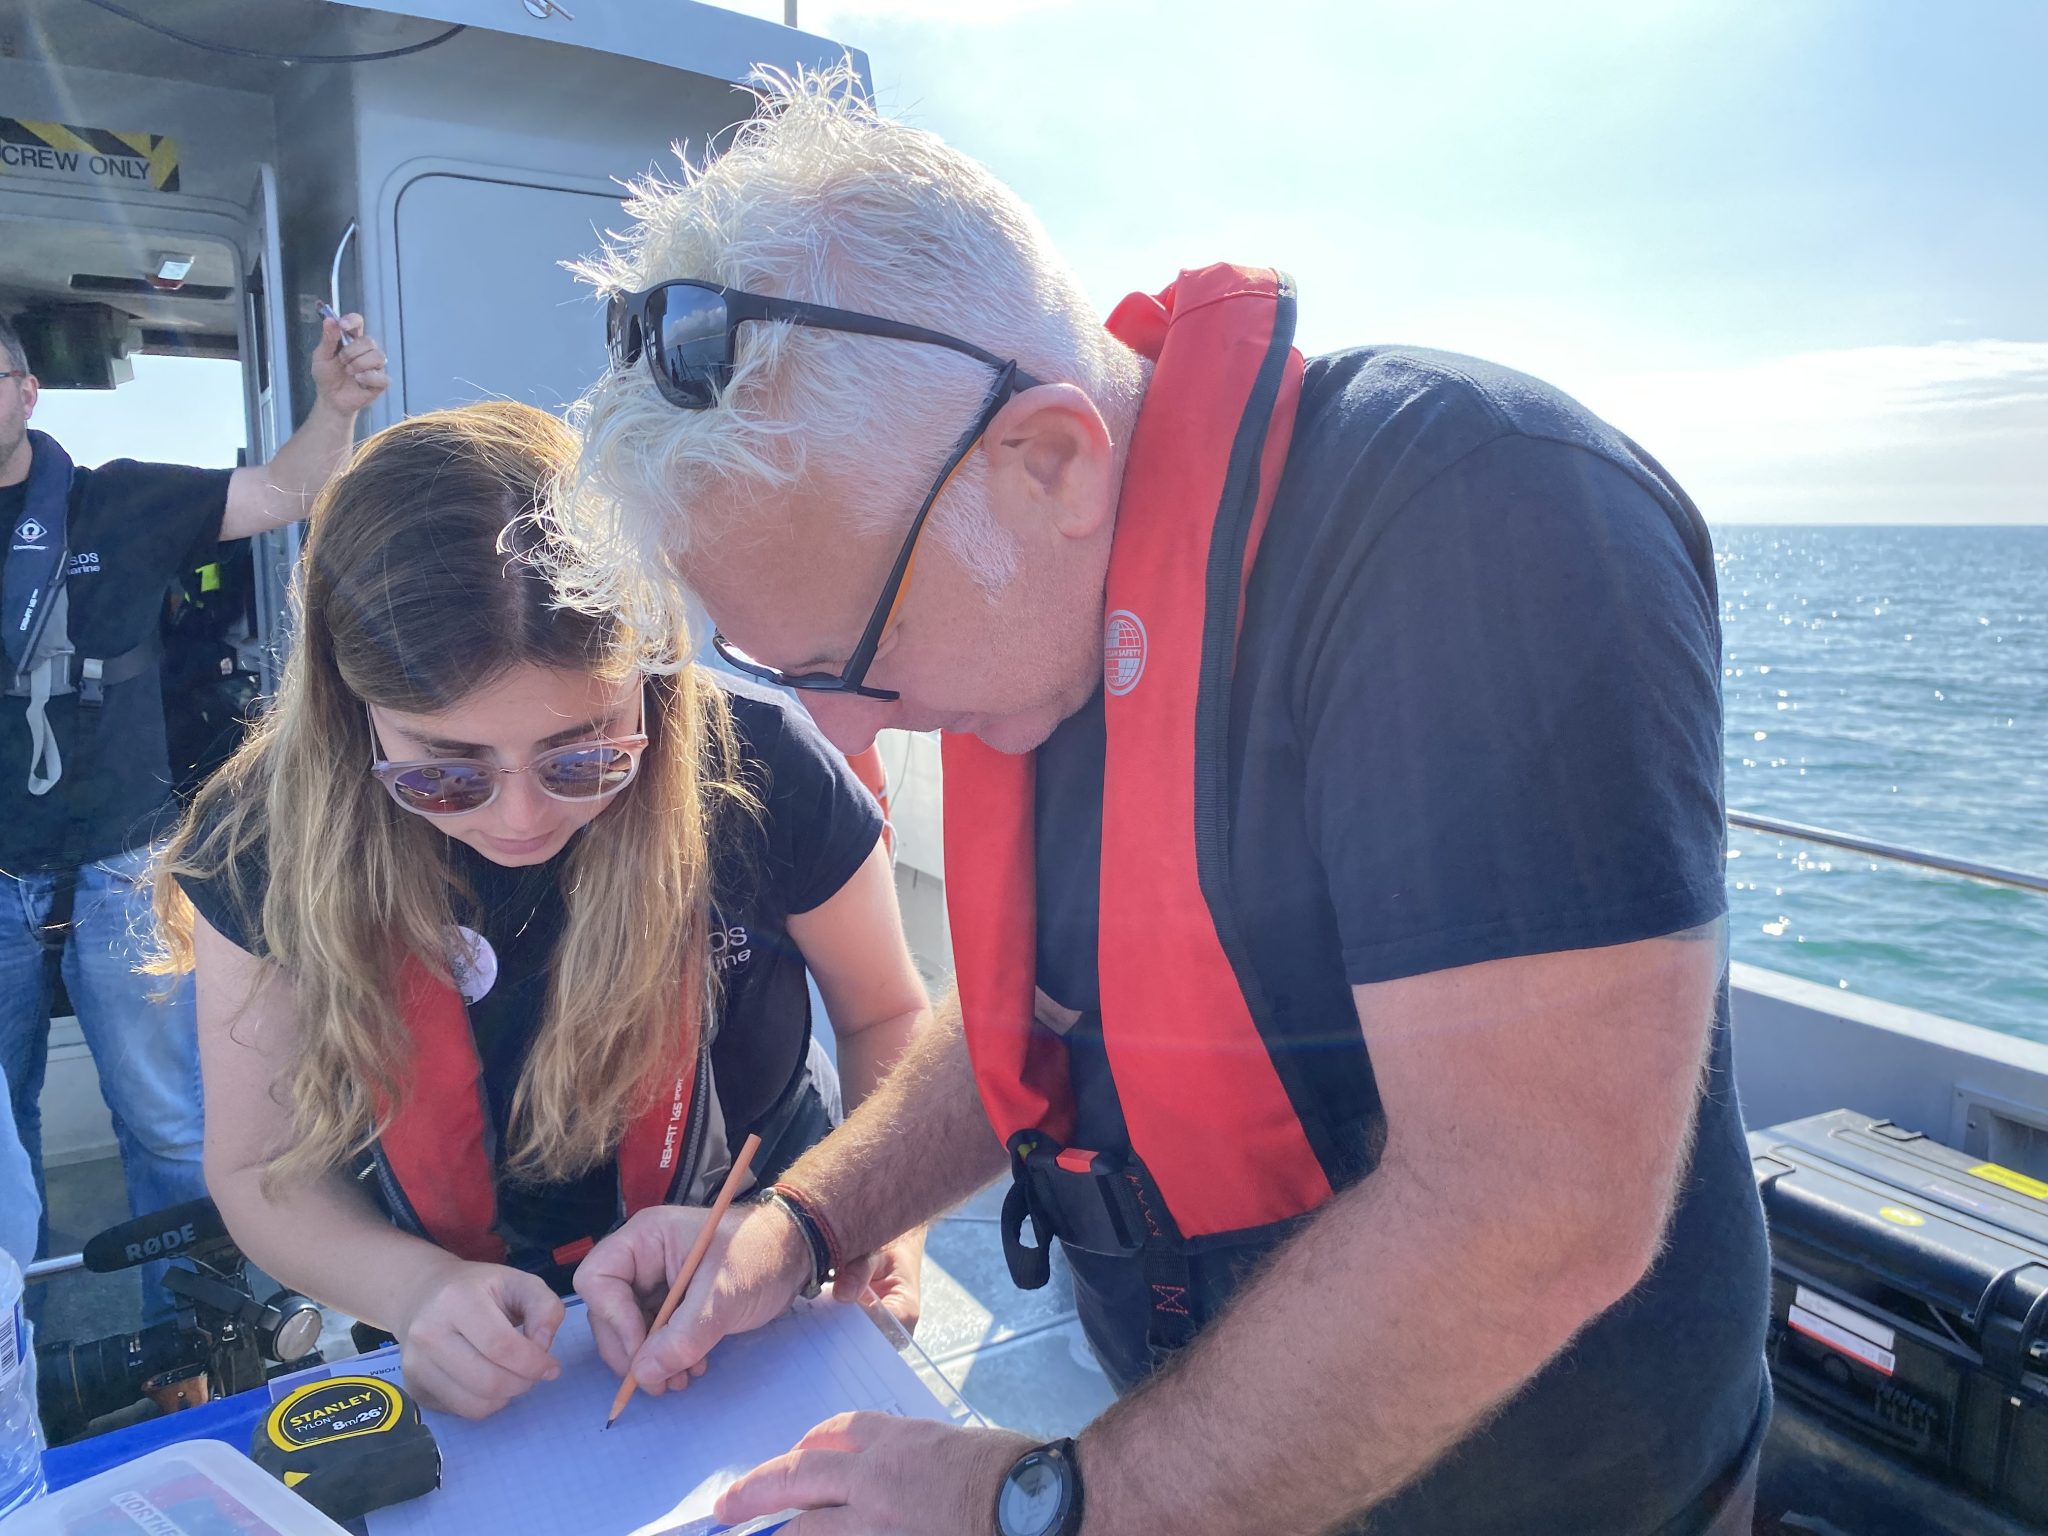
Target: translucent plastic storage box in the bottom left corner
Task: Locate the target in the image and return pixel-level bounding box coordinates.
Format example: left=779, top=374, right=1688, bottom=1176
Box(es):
left=0, top=1440, right=348, bottom=1536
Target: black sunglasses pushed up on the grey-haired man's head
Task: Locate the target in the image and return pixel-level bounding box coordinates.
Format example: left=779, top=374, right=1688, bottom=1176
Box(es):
left=604, top=279, right=1038, bottom=412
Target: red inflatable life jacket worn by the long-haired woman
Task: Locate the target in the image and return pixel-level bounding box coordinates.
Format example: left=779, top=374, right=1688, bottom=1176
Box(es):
left=375, top=954, right=696, bottom=1264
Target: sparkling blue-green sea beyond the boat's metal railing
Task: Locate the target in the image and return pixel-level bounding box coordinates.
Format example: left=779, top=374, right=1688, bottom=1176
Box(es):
left=1714, top=526, right=2048, bottom=1040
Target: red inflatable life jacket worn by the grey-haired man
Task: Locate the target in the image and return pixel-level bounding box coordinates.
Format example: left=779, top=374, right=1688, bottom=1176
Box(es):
left=944, top=266, right=1341, bottom=1335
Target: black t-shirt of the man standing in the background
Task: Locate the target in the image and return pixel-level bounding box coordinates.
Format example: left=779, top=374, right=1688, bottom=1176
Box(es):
left=0, top=459, right=233, bottom=874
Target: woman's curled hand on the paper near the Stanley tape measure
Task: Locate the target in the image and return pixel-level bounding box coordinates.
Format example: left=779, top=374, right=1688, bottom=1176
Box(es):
left=393, top=1255, right=561, bottom=1419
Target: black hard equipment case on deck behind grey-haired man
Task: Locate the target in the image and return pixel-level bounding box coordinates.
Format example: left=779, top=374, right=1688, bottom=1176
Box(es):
left=1749, top=1110, right=2048, bottom=1522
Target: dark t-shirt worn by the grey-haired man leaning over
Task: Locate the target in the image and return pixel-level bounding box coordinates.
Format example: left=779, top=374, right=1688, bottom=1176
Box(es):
left=1036, top=348, right=1769, bottom=1536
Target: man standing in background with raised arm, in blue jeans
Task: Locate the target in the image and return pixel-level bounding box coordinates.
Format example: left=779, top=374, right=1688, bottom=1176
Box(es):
left=0, top=315, right=389, bottom=1317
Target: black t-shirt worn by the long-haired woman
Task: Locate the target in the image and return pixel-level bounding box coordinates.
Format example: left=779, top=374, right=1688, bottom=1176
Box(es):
left=184, top=676, right=883, bottom=1249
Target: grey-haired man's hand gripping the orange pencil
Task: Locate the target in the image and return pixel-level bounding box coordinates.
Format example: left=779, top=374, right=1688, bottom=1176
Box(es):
left=575, top=1206, right=811, bottom=1393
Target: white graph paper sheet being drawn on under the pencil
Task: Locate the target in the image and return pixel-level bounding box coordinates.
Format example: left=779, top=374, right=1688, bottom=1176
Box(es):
left=367, top=1300, right=948, bottom=1536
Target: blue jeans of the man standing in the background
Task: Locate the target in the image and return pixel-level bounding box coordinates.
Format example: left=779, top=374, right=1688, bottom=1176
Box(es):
left=0, top=848, right=207, bottom=1321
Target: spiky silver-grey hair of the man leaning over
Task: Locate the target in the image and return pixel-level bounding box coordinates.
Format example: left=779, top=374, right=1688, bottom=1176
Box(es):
left=553, top=66, right=1145, bottom=663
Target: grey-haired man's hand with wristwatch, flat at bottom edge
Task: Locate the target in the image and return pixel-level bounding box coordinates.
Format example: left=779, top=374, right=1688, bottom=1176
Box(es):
left=717, top=1413, right=1038, bottom=1536
